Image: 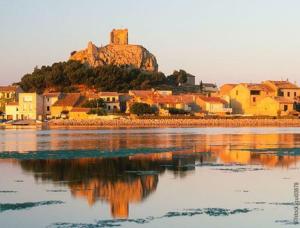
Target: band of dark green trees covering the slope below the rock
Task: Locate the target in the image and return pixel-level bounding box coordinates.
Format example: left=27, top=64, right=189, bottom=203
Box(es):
left=18, top=60, right=187, bottom=93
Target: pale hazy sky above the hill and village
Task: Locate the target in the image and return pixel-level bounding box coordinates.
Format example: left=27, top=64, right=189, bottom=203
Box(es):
left=0, top=0, right=300, bottom=85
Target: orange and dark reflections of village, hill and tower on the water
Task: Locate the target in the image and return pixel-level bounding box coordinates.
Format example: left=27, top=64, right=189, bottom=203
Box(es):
left=0, top=128, right=300, bottom=218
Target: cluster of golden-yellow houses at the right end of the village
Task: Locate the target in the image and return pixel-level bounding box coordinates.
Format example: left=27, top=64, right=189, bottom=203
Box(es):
left=219, top=80, right=300, bottom=116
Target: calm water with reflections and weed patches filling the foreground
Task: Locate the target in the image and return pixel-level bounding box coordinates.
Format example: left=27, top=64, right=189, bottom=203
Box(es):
left=0, top=128, right=300, bottom=228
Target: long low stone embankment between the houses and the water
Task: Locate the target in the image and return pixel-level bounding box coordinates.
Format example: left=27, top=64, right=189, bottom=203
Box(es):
left=48, top=119, right=300, bottom=128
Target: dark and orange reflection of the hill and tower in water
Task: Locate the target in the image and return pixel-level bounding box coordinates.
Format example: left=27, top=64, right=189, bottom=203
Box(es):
left=20, top=153, right=196, bottom=218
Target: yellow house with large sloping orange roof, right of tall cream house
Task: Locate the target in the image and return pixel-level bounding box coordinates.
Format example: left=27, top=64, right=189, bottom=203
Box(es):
left=50, top=93, right=84, bottom=118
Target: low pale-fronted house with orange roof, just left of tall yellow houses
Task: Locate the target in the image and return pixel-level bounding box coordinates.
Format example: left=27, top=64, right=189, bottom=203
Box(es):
left=196, top=96, right=232, bottom=115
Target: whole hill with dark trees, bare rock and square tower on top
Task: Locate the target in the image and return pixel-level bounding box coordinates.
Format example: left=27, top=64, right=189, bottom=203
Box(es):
left=18, top=29, right=193, bottom=93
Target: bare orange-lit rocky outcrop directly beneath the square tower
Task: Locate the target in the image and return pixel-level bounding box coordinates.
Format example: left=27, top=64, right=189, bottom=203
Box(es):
left=70, top=42, right=158, bottom=71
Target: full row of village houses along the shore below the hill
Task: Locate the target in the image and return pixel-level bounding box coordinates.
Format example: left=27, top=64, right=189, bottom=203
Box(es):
left=0, top=78, right=300, bottom=124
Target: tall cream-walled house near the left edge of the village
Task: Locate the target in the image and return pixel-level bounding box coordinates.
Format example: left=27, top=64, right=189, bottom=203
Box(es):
left=18, top=93, right=43, bottom=120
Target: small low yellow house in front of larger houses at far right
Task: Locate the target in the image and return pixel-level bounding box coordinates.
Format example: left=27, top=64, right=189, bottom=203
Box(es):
left=256, top=97, right=294, bottom=116
